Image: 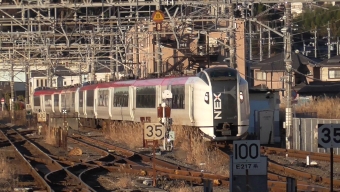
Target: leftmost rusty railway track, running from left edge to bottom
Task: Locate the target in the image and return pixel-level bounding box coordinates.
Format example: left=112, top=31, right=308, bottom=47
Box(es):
left=1, top=124, right=94, bottom=191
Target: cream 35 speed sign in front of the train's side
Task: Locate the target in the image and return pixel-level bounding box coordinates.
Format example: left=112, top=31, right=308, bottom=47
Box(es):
left=144, top=123, right=165, bottom=140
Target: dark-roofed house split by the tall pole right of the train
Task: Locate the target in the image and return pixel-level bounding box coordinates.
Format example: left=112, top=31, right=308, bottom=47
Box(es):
left=250, top=51, right=319, bottom=96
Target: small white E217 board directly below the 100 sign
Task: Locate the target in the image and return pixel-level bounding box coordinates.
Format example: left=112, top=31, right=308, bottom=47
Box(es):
left=233, top=157, right=268, bottom=175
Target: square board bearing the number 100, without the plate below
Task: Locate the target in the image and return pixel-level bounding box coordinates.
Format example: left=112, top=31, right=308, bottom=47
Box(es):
left=233, top=140, right=261, bottom=163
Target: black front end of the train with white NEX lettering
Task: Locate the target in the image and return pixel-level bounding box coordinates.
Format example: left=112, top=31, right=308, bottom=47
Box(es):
left=205, top=67, right=250, bottom=141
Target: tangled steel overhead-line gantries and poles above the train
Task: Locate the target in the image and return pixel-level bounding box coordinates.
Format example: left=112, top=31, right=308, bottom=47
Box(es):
left=0, top=0, right=340, bottom=146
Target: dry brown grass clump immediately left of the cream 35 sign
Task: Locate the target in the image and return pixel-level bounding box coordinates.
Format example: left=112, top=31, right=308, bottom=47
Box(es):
left=105, top=122, right=143, bottom=148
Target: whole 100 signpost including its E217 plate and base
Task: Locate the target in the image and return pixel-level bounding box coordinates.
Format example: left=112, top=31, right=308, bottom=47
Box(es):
left=230, top=140, right=268, bottom=191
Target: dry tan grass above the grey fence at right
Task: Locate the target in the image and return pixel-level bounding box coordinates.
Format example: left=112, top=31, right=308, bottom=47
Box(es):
left=280, top=97, right=340, bottom=119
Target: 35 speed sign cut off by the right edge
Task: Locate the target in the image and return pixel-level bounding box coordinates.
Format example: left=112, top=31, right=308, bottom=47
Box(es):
left=318, top=124, right=340, bottom=148
